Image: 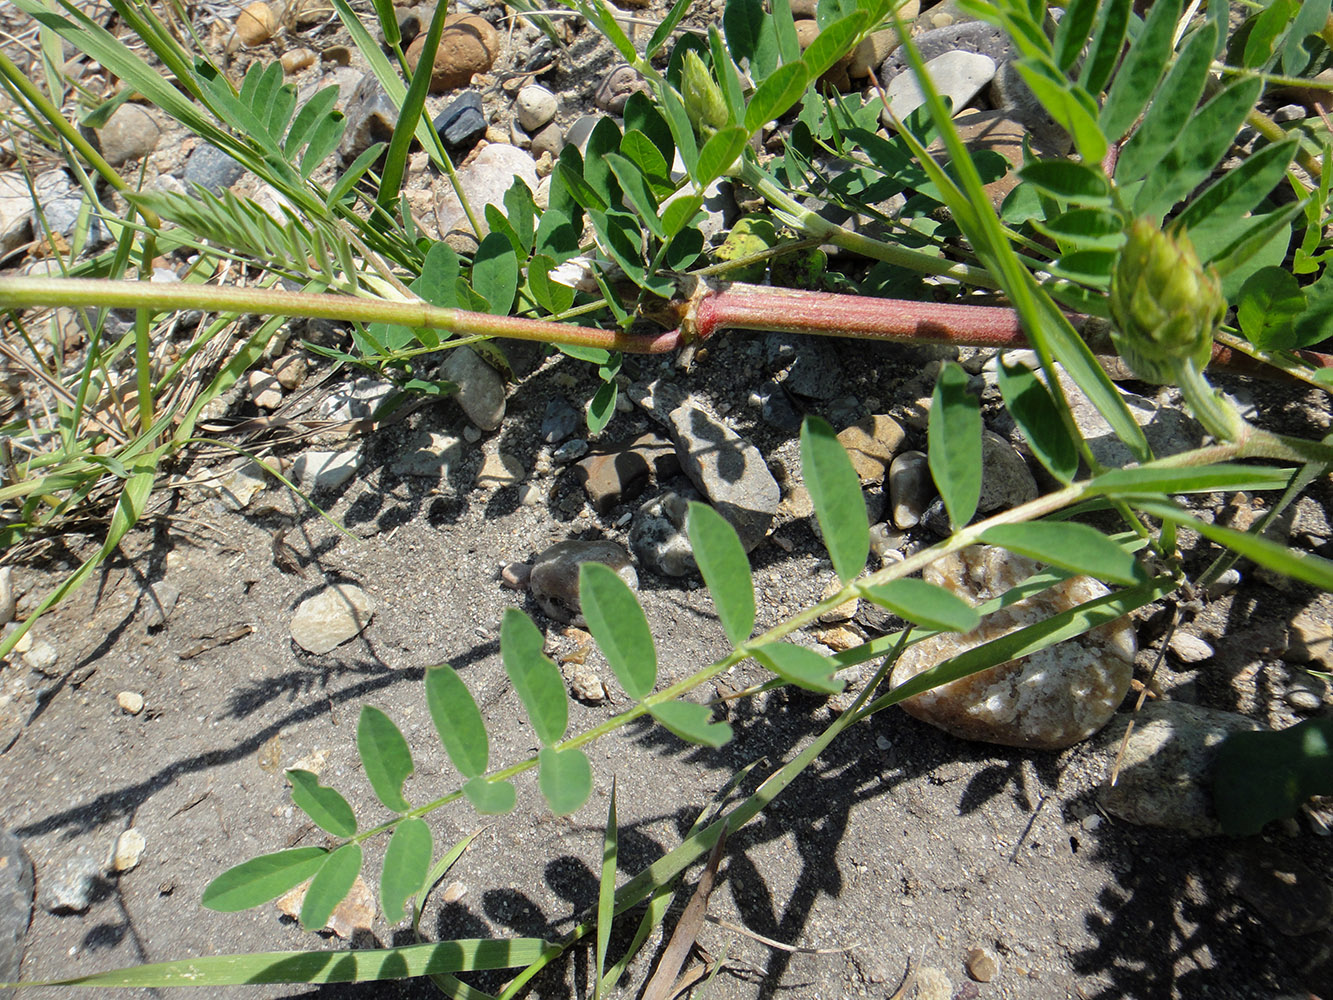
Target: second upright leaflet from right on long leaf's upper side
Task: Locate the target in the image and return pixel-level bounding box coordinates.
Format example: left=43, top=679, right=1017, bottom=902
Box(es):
left=801, top=416, right=869, bottom=583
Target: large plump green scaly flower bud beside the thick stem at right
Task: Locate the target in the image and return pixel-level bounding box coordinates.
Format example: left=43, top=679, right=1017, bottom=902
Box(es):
left=1110, top=219, right=1226, bottom=383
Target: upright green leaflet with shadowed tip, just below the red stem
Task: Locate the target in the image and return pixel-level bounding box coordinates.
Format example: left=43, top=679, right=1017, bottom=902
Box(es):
left=933, top=361, right=981, bottom=528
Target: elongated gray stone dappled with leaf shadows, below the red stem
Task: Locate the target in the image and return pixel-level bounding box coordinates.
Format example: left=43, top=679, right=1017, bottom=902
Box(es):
left=669, top=403, right=781, bottom=552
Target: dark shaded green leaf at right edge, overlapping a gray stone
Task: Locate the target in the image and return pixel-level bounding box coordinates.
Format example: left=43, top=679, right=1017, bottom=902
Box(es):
left=1213, top=719, right=1333, bottom=837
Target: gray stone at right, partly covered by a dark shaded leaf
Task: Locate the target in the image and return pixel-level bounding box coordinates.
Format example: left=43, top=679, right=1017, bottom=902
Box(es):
left=1098, top=701, right=1262, bottom=836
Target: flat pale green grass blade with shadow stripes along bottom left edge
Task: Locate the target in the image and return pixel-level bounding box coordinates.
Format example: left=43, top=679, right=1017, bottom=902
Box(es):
left=16, top=937, right=552, bottom=989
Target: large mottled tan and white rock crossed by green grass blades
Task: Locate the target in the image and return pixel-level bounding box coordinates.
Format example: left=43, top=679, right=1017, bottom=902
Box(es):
left=892, top=545, right=1137, bottom=749
